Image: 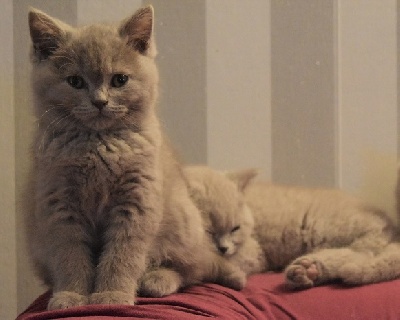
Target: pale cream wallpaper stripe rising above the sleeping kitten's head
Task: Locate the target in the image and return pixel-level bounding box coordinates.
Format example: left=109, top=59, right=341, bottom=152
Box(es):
left=206, top=0, right=271, bottom=177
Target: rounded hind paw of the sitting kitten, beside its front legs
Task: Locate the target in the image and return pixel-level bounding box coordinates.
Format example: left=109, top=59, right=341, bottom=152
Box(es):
left=140, top=272, right=182, bottom=298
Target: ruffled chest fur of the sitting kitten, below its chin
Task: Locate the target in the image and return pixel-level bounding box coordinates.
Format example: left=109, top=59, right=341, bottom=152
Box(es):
left=37, top=132, right=155, bottom=222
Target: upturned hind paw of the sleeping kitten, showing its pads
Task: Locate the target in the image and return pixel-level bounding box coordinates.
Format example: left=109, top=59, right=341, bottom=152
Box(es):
left=285, top=259, right=320, bottom=288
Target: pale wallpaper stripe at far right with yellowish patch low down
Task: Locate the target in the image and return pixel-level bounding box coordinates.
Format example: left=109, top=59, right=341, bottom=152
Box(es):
left=338, top=0, right=398, bottom=220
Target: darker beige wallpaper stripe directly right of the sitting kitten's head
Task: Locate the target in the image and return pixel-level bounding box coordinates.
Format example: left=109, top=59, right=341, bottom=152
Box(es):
left=145, top=0, right=207, bottom=163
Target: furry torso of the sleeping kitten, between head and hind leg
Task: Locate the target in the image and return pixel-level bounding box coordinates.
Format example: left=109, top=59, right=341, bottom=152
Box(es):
left=245, top=182, right=392, bottom=269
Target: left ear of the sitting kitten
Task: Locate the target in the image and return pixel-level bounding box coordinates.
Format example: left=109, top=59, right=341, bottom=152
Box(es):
left=29, top=9, right=67, bottom=61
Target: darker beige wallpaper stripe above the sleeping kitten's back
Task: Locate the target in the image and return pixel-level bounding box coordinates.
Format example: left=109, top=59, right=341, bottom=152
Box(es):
left=271, top=0, right=336, bottom=187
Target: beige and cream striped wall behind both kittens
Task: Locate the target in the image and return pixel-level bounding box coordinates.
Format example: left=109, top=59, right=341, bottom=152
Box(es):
left=0, top=0, right=399, bottom=319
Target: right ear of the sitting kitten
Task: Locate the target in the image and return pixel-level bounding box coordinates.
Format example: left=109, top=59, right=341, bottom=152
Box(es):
left=119, top=6, right=156, bottom=58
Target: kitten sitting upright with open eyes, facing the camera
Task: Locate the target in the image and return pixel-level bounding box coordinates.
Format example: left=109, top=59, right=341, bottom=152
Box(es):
left=26, top=7, right=245, bottom=309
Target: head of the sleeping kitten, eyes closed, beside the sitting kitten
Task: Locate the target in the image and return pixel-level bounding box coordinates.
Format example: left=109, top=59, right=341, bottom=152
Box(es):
left=184, top=166, right=267, bottom=274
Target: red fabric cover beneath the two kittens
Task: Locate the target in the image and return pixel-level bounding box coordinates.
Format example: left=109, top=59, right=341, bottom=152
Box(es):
left=17, top=273, right=400, bottom=320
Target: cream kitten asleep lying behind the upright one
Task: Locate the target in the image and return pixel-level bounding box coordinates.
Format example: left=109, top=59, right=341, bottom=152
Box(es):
left=185, top=167, right=400, bottom=288
